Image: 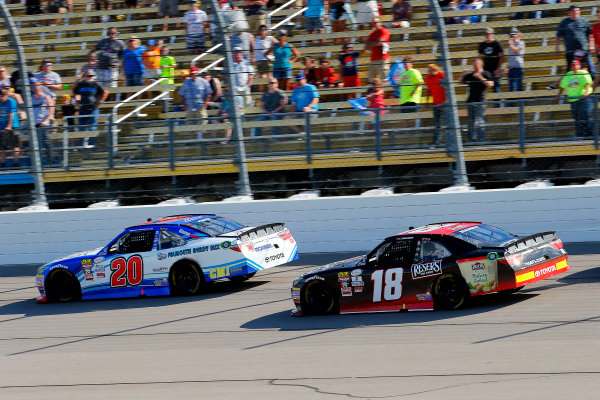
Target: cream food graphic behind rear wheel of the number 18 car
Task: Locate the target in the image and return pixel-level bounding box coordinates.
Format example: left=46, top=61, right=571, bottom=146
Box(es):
left=458, top=253, right=498, bottom=294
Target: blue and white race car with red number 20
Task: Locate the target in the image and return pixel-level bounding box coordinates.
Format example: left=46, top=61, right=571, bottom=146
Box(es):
left=36, top=214, right=298, bottom=303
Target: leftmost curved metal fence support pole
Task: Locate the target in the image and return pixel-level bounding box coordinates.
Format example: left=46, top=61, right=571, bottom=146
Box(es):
left=0, top=1, right=47, bottom=204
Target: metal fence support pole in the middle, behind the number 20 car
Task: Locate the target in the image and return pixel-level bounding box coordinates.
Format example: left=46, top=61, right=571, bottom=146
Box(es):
left=211, top=0, right=252, bottom=196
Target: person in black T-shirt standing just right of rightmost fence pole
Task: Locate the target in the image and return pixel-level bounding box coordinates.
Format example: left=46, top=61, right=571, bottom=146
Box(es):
left=460, top=58, right=494, bottom=142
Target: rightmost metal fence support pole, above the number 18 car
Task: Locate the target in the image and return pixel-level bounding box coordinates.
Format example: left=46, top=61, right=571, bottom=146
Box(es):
left=429, top=0, right=469, bottom=185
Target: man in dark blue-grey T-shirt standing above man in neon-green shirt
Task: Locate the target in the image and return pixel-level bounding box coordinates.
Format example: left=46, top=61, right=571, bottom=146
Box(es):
left=554, top=5, right=591, bottom=68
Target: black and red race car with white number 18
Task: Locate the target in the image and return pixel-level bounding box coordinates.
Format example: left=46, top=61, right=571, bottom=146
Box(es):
left=292, top=222, right=569, bottom=315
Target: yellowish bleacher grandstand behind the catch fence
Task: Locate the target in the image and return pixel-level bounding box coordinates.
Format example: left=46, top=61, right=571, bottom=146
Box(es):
left=0, top=0, right=600, bottom=207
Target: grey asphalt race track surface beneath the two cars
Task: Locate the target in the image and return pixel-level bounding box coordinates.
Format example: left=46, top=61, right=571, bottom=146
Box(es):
left=0, top=248, right=600, bottom=400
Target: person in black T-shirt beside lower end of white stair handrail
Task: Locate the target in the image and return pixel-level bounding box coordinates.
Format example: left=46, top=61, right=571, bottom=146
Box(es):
left=73, top=70, right=109, bottom=147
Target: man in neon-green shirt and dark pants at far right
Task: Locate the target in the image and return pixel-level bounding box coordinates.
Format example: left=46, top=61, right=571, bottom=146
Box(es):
left=558, top=60, right=593, bottom=137
